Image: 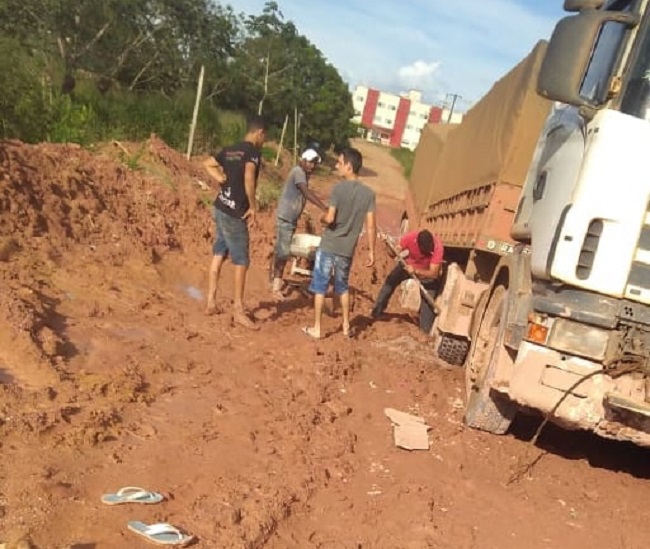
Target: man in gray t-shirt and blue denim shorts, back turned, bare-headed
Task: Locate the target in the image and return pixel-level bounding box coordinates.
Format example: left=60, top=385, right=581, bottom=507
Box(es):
left=302, top=148, right=377, bottom=339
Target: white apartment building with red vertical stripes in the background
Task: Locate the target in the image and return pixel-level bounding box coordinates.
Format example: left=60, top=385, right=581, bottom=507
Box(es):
left=352, top=86, right=463, bottom=150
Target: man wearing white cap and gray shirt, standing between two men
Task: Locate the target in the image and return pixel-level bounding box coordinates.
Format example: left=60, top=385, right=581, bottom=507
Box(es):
left=271, top=148, right=327, bottom=299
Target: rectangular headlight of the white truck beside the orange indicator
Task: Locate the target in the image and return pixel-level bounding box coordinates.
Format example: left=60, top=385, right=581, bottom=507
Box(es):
left=547, top=318, right=609, bottom=360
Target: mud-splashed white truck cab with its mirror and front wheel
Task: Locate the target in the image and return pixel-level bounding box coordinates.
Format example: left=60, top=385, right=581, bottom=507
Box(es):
left=465, top=0, right=650, bottom=446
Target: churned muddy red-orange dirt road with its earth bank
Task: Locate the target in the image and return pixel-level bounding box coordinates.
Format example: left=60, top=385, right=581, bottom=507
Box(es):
left=0, top=140, right=650, bottom=549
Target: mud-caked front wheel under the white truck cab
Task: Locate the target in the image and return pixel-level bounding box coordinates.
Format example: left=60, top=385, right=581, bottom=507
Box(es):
left=465, top=286, right=516, bottom=435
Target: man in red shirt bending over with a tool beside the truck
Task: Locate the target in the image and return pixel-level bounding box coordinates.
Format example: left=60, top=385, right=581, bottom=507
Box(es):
left=371, top=230, right=445, bottom=332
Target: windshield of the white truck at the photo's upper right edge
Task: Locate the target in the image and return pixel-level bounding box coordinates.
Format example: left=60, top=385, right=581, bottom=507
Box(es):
left=621, top=8, right=650, bottom=121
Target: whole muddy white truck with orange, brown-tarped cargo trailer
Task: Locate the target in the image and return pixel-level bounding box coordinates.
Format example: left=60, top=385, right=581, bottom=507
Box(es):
left=404, top=0, right=650, bottom=447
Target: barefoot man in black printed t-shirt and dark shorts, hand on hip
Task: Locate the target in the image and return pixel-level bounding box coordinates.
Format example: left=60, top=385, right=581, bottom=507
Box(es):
left=204, top=116, right=266, bottom=329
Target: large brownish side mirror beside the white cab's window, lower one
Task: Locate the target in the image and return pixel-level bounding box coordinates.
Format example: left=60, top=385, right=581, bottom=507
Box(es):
left=537, top=9, right=639, bottom=108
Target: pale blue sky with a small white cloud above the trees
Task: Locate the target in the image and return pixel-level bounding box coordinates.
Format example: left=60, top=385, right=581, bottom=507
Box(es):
left=220, top=0, right=568, bottom=110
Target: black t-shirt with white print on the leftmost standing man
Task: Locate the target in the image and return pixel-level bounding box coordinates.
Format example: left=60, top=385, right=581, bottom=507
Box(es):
left=214, top=141, right=260, bottom=217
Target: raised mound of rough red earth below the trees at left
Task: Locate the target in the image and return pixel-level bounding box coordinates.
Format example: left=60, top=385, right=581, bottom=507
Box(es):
left=0, top=140, right=218, bottom=260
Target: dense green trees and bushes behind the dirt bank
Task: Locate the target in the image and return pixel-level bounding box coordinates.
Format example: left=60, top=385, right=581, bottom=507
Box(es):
left=0, top=0, right=352, bottom=152
